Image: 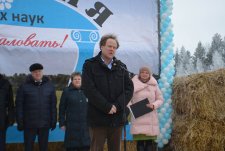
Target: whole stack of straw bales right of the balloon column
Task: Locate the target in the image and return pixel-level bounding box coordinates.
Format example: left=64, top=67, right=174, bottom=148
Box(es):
left=172, top=69, right=225, bottom=151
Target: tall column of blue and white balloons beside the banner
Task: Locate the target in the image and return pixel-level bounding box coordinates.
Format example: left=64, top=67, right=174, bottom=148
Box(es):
left=156, top=0, right=175, bottom=148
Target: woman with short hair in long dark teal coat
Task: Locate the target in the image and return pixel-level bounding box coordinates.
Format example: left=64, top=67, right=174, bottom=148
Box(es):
left=59, top=72, right=90, bottom=151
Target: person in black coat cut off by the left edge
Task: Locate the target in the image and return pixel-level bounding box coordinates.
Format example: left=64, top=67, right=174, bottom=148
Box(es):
left=0, top=74, right=15, bottom=151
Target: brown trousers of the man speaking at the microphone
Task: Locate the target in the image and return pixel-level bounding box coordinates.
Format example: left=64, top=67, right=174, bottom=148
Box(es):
left=90, top=127, right=122, bottom=151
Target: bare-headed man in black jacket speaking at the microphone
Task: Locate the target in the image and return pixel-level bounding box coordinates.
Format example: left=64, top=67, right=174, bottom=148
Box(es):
left=82, top=35, right=133, bottom=151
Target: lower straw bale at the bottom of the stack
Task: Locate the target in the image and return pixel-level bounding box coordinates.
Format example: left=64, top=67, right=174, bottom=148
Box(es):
left=172, top=117, right=225, bottom=151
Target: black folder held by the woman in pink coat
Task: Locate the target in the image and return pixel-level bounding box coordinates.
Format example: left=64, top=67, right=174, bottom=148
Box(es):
left=130, top=98, right=152, bottom=118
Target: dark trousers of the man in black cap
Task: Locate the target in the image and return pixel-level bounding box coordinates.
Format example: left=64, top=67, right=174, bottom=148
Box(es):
left=24, top=128, right=49, bottom=151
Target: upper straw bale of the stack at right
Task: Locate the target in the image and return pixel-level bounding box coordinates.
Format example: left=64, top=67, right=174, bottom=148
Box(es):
left=173, top=70, right=225, bottom=122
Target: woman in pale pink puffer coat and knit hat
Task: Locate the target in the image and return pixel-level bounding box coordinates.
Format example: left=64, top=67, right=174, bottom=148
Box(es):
left=128, top=67, right=163, bottom=151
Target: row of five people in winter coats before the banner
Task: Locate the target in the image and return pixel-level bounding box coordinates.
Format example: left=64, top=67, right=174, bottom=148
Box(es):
left=0, top=34, right=163, bottom=151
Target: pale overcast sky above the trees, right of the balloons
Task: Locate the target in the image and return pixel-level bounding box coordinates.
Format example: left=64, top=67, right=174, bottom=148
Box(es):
left=172, top=0, right=225, bottom=54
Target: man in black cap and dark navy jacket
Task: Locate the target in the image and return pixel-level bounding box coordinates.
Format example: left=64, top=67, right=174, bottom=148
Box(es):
left=16, top=63, right=57, bottom=151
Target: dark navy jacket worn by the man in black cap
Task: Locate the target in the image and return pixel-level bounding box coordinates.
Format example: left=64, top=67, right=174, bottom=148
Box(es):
left=16, top=76, right=57, bottom=128
